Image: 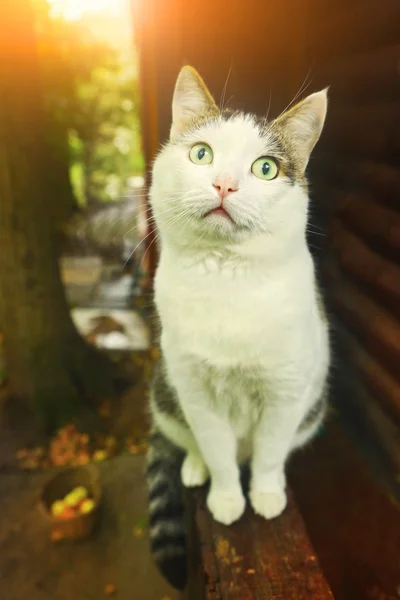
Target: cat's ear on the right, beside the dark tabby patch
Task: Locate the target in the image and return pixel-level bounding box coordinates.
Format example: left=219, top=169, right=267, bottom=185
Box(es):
left=275, top=88, right=328, bottom=170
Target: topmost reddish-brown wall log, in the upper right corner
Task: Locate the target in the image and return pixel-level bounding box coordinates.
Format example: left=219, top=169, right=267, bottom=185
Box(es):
left=310, top=0, right=400, bottom=59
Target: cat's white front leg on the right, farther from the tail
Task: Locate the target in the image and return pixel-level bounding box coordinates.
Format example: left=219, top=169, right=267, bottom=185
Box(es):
left=250, top=383, right=316, bottom=519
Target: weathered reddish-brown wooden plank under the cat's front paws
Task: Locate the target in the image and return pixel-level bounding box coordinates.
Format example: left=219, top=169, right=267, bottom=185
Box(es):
left=187, top=491, right=333, bottom=600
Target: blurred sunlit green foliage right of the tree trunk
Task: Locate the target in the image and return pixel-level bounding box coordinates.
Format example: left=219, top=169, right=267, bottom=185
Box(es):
left=35, top=0, right=144, bottom=205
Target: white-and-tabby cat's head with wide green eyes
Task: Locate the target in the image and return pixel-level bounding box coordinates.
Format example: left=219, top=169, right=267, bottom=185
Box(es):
left=151, top=67, right=327, bottom=245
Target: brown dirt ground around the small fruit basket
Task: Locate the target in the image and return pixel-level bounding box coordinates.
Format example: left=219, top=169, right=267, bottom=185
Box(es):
left=0, top=456, right=179, bottom=600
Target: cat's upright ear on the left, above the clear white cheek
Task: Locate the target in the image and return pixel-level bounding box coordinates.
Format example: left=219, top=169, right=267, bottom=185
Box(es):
left=171, top=66, right=218, bottom=139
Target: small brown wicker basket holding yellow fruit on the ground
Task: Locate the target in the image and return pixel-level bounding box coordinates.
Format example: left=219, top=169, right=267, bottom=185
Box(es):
left=39, top=465, right=101, bottom=542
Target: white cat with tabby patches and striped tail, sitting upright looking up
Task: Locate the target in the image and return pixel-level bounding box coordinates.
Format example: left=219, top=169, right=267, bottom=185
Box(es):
left=147, top=66, right=330, bottom=589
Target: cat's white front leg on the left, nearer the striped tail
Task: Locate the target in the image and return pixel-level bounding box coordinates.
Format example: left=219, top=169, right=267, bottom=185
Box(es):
left=164, top=361, right=245, bottom=525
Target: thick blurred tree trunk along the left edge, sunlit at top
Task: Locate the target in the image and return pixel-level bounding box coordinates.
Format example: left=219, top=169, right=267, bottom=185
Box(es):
left=0, top=0, right=112, bottom=428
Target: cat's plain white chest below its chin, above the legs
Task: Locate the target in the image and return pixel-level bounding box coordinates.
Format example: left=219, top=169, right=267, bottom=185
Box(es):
left=155, top=248, right=310, bottom=367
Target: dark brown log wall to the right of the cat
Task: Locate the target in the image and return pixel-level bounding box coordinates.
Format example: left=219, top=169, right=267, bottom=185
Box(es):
left=308, top=0, right=400, bottom=465
